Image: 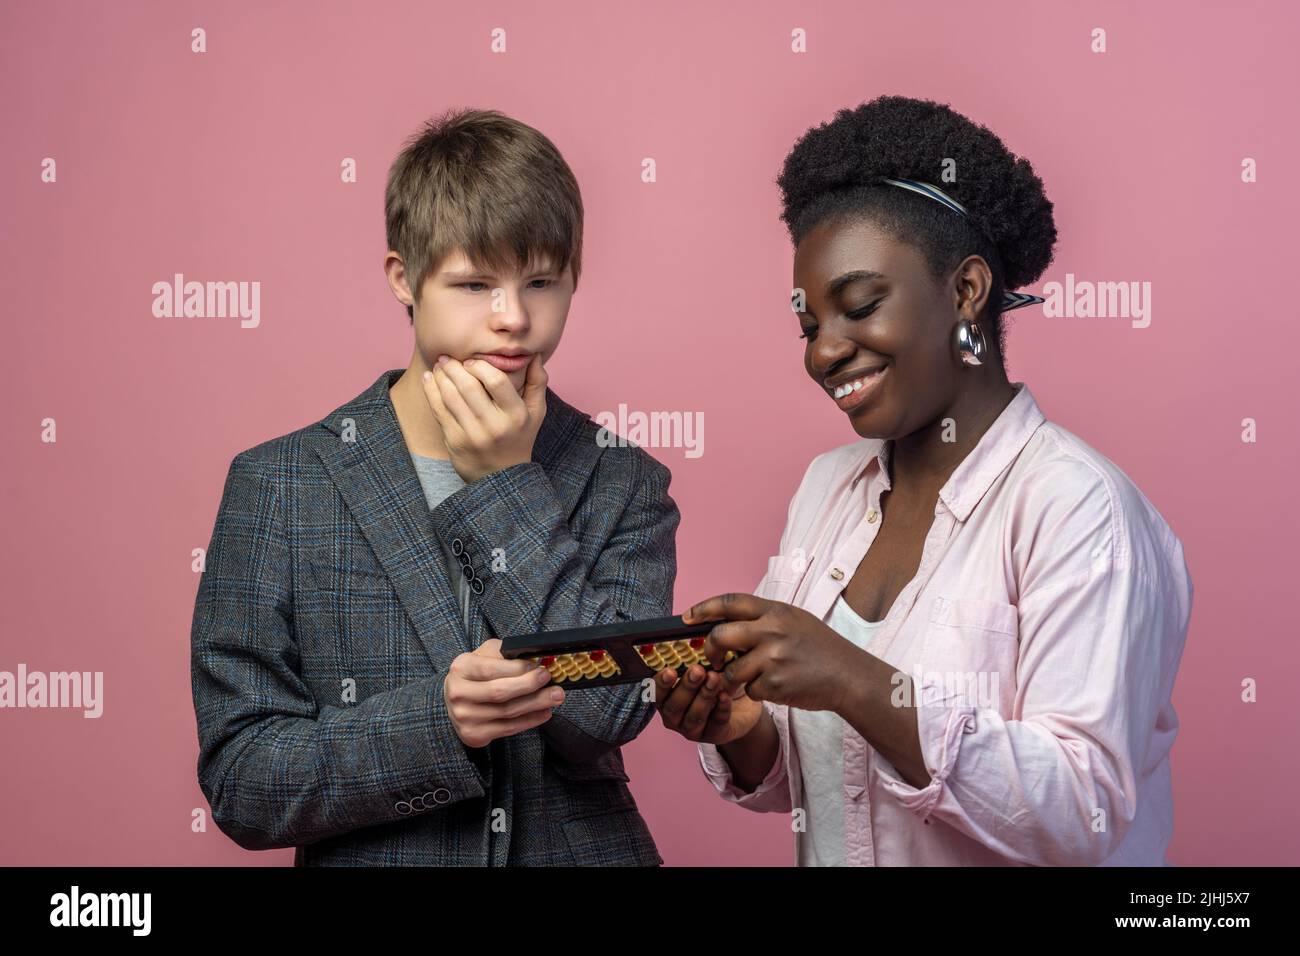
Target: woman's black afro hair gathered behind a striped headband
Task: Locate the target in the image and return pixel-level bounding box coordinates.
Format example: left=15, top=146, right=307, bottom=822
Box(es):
left=776, top=96, right=1057, bottom=368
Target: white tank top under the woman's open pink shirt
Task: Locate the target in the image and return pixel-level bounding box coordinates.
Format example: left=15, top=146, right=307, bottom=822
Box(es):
left=790, top=594, right=884, bottom=866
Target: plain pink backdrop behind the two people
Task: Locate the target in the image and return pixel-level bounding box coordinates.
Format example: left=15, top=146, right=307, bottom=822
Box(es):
left=0, top=0, right=1300, bottom=865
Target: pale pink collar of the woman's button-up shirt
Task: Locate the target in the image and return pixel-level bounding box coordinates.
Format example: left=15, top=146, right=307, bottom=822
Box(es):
left=853, top=382, right=1047, bottom=522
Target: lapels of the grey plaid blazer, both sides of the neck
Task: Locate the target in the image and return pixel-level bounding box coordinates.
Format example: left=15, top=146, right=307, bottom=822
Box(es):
left=316, top=368, right=599, bottom=671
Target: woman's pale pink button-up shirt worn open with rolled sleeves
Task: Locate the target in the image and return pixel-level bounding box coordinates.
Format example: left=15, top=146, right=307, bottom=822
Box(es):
left=699, top=382, right=1192, bottom=866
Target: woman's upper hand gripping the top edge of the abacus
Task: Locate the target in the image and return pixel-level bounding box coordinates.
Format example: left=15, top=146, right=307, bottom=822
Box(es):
left=681, top=594, right=871, bottom=714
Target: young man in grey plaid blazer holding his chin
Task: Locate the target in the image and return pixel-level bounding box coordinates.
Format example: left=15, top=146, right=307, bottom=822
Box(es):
left=192, top=111, right=680, bottom=866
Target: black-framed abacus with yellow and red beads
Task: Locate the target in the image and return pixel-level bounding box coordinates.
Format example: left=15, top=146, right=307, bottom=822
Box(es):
left=501, top=614, right=736, bottom=689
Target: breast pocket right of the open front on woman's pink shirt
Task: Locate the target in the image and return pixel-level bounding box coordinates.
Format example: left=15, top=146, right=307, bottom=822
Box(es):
left=913, top=596, right=1021, bottom=719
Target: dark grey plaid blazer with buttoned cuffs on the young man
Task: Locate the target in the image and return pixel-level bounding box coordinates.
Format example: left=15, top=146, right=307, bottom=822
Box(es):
left=191, top=369, right=680, bottom=866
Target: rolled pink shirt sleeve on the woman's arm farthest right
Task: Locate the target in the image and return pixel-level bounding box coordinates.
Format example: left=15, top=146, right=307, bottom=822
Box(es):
left=872, top=470, right=1191, bottom=865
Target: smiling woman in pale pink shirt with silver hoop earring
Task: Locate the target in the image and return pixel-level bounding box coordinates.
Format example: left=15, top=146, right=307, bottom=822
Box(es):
left=657, top=96, right=1192, bottom=865
